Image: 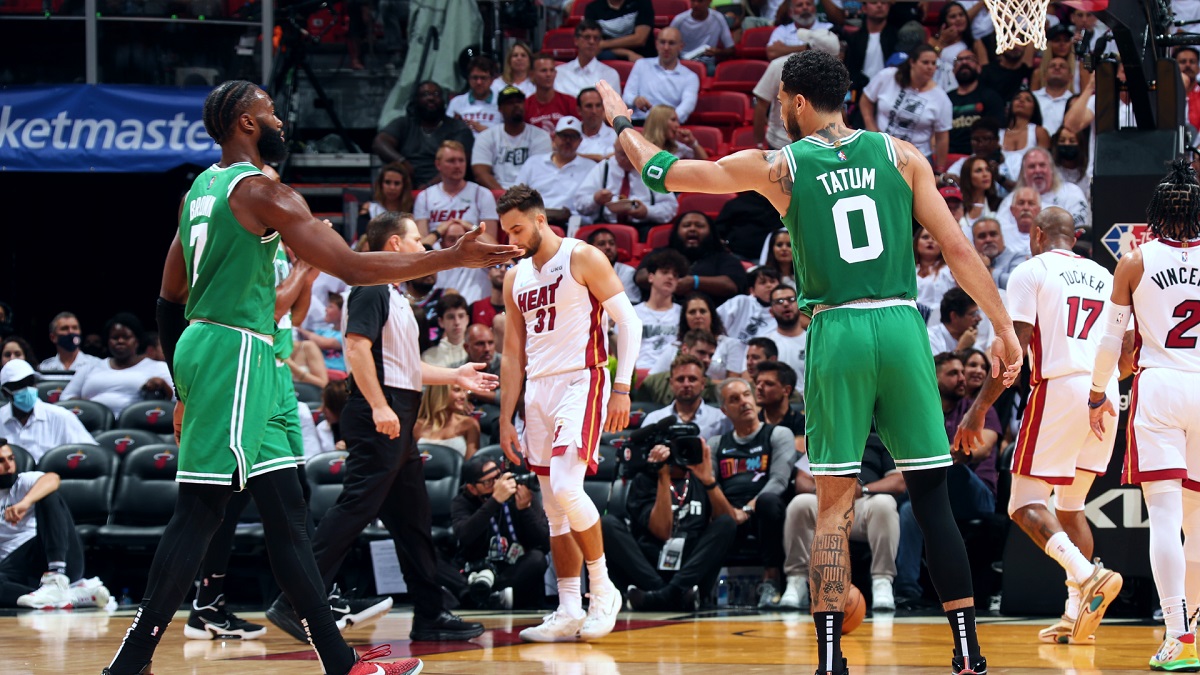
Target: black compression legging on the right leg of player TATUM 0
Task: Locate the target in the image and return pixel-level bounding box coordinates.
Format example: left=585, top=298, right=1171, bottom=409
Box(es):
left=904, top=467, right=974, bottom=603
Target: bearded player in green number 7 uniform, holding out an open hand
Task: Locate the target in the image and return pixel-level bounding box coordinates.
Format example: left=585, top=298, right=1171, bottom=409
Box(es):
left=103, top=80, right=520, bottom=675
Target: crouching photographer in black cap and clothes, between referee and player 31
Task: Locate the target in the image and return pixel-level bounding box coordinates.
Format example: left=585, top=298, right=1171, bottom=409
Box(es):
left=450, top=456, right=550, bottom=609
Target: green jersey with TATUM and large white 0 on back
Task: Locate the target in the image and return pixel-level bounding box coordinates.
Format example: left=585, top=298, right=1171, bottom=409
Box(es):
left=781, top=131, right=917, bottom=312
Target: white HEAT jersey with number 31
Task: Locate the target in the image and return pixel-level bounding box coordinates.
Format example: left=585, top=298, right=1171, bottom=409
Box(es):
left=512, top=239, right=608, bottom=380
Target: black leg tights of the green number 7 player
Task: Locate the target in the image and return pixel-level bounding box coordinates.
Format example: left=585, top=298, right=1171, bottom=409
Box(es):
left=109, top=470, right=356, bottom=675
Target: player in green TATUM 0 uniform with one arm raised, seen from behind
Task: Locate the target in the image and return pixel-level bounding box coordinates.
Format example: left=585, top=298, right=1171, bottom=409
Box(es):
left=596, top=50, right=1020, bottom=675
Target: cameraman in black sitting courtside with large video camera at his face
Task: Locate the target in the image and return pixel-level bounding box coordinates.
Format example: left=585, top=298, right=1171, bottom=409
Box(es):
left=601, top=418, right=738, bottom=611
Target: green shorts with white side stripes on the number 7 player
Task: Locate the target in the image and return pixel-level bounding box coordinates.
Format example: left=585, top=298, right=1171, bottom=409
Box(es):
left=175, top=323, right=295, bottom=490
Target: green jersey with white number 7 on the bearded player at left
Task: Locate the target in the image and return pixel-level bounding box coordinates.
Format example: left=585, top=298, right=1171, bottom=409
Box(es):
left=179, top=162, right=280, bottom=335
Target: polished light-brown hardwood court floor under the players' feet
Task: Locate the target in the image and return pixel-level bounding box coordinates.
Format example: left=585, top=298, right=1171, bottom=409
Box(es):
left=0, top=610, right=1163, bottom=675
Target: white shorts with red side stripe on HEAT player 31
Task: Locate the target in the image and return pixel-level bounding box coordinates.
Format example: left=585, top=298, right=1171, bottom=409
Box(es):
left=524, top=368, right=608, bottom=476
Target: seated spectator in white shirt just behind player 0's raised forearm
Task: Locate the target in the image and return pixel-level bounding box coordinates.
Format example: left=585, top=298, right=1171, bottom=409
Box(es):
left=574, top=141, right=679, bottom=226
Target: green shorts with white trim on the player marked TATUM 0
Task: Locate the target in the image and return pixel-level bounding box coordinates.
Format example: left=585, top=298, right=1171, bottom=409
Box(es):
left=804, top=304, right=953, bottom=476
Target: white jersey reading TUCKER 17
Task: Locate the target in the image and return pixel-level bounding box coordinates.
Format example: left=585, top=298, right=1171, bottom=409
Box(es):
left=1007, top=250, right=1112, bottom=384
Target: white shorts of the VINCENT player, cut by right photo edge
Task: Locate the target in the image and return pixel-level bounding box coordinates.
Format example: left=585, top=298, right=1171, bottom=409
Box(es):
left=1122, top=368, right=1200, bottom=491
